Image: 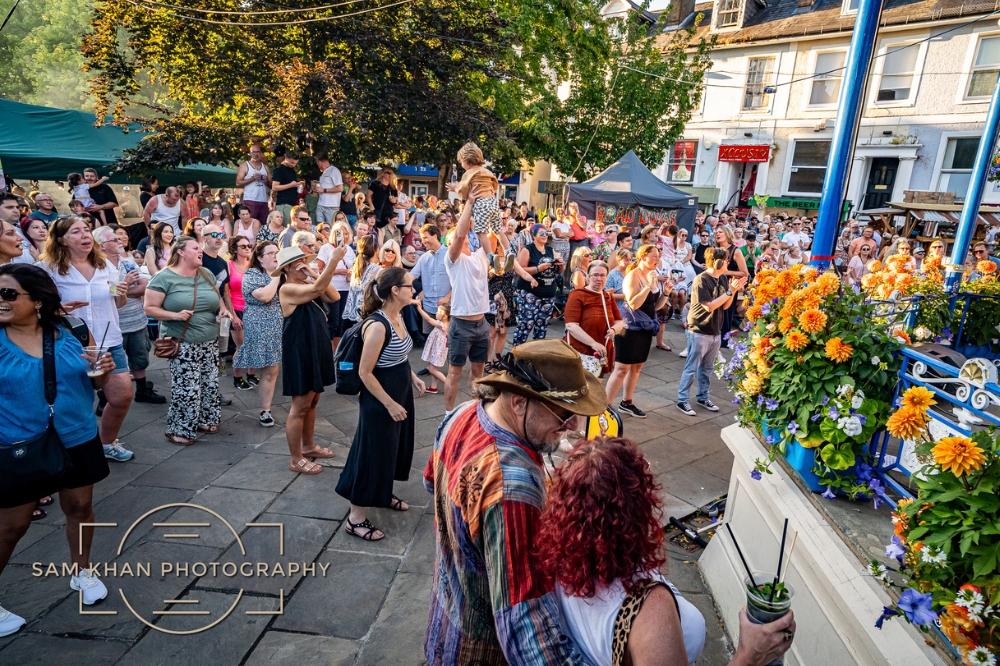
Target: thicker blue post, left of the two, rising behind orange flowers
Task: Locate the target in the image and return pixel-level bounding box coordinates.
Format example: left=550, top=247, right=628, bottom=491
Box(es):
left=811, top=0, right=883, bottom=270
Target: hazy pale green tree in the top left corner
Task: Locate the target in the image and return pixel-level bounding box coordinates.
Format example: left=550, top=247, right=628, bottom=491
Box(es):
left=0, top=0, right=93, bottom=110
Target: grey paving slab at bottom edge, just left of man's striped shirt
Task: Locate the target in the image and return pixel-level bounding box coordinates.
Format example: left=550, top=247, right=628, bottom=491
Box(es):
left=356, top=573, right=431, bottom=666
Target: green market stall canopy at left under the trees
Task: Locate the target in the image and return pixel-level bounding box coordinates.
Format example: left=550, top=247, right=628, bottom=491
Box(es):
left=0, top=99, right=236, bottom=187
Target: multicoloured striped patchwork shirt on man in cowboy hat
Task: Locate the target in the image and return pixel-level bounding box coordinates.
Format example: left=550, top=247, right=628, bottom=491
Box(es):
left=424, top=402, right=585, bottom=666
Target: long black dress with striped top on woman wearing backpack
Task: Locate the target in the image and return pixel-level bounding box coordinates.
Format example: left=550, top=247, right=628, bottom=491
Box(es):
left=337, top=310, right=414, bottom=506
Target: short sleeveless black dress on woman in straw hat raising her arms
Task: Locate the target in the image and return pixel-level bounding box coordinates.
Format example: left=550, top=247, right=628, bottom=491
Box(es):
left=281, top=294, right=336, bottom=396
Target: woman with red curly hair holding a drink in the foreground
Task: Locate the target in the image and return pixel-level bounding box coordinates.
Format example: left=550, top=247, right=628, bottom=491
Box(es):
left=535, top=438, right=795, bottom=666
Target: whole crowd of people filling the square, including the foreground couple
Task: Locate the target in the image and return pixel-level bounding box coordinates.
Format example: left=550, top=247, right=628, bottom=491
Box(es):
left=19, top=143, right=1000, bottom=664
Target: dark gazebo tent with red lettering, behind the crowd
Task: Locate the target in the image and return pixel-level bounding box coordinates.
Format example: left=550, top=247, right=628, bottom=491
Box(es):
left=566, top=150, right=698, bottom=234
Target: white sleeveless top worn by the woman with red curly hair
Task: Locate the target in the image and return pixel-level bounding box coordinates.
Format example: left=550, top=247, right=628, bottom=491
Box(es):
left=556, top=574, right=706, bottom=666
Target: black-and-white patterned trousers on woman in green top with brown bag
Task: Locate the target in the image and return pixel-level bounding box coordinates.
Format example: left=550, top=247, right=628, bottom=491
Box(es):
left=167, top=338, right=222, bottom=439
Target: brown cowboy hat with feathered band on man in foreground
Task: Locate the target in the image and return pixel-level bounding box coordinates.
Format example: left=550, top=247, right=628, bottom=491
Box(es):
left=476, top=339, right=608, bottom=416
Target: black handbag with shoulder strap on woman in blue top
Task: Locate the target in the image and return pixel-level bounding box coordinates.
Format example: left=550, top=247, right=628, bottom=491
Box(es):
left=0, top=331, right=73, bottom=494
